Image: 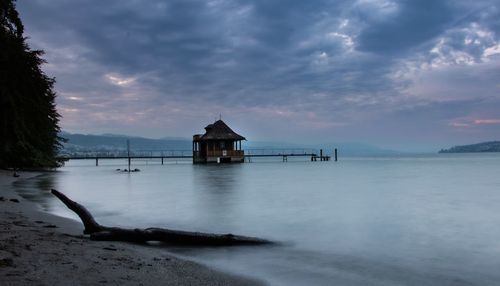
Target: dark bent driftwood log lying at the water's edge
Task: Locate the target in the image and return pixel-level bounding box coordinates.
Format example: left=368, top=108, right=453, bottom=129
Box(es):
left=52, top=189, right=273, bottom=246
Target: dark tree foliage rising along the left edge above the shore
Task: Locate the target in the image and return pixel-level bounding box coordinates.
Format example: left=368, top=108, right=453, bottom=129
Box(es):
left=0, top=0, right=62, bottom=168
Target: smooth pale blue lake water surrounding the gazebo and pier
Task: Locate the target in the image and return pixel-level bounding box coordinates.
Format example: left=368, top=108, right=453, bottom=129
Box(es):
left=12, top=154, right=500, bottom=286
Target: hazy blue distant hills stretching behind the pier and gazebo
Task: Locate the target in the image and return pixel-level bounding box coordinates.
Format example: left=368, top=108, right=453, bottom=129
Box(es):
left=60, top=132, right=400, bottom=156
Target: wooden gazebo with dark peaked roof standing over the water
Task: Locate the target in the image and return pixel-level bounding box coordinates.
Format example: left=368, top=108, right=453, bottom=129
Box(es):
left=193, top=120, right=246, bottom=164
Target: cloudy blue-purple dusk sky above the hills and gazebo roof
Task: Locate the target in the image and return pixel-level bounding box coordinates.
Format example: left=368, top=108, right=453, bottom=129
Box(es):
left=17, top=0, right=500, bottom=151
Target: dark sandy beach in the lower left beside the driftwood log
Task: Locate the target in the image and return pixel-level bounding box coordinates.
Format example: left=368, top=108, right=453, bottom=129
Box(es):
left=0, top=170, right=264, bottom=285
